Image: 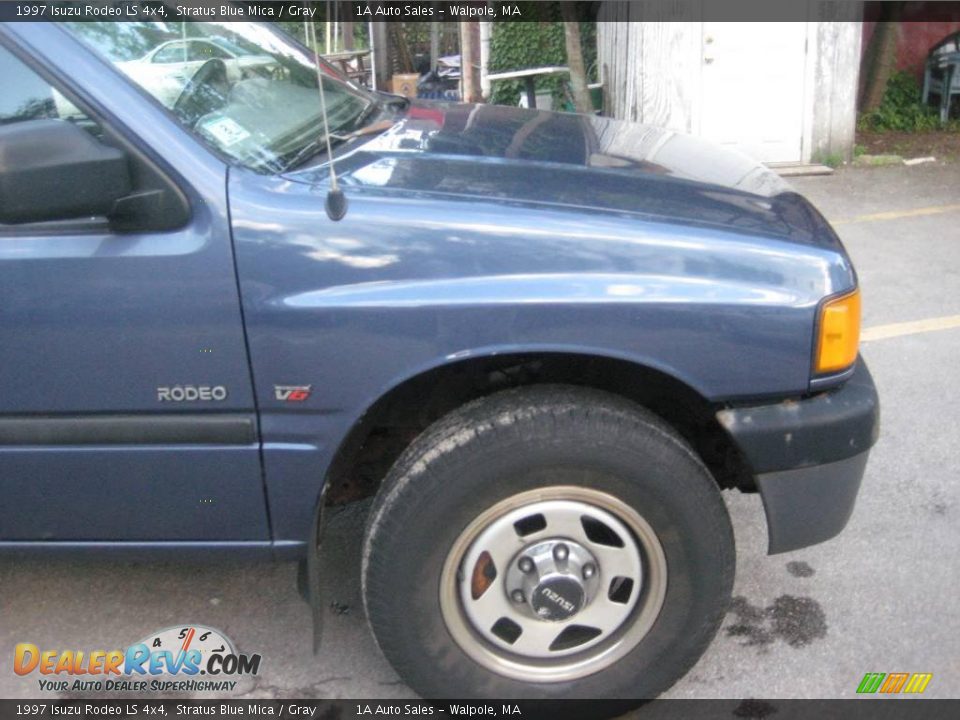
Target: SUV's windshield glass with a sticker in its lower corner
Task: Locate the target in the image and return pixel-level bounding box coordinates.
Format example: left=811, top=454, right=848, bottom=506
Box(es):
left=65, top=22, right=375, bottom=172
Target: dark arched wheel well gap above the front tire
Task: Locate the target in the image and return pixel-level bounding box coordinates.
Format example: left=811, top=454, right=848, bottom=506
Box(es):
left=326, top=353, right=753, bottom=504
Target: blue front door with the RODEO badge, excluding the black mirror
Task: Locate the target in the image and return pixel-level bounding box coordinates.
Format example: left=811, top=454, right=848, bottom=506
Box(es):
left=0, top=32, right=269, bottom=546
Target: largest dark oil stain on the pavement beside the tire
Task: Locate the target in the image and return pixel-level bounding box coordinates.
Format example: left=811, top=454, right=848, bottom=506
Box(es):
left=727, top=595, right=827, bottom=648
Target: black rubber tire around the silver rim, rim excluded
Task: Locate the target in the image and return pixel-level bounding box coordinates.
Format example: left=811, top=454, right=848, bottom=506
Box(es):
left=362, top=385, right=735, bottom=699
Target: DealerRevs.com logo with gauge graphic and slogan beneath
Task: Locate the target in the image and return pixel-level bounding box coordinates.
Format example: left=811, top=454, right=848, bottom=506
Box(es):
left=13, top=625, right=260, bottom=692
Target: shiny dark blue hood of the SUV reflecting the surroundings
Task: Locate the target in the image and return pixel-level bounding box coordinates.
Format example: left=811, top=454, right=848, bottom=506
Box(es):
left=289, top=103, right=837, bottom=246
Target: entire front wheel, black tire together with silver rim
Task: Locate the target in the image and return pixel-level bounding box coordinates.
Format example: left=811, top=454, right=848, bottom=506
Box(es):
left=363, top=386, right=734, bottom=699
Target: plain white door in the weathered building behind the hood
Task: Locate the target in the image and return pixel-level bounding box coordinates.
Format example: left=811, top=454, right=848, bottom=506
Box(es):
left=700, top=22, right=807, bottom=162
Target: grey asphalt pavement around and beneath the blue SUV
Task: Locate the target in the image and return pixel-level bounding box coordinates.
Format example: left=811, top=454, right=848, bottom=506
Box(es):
left=0, top=164, right=960, bottom=699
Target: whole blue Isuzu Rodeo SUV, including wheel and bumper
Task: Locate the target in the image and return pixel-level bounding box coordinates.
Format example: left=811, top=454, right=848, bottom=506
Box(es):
left=0, top=22, right=878, bottom=698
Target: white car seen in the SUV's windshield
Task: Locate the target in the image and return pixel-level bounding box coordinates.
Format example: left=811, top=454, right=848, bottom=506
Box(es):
left=117, top=38, right=279, bottom=107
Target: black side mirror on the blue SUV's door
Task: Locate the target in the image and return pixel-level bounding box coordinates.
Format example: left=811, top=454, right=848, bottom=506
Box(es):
left=0, top=120, right=131, bottom=224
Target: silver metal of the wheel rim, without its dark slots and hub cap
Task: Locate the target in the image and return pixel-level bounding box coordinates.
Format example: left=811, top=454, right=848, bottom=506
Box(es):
left=439, top=486, right=667, bottom=682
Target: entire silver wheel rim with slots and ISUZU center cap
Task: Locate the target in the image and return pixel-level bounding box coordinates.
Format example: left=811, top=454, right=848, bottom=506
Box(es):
left=440, top=486, right=667, bottom=682
